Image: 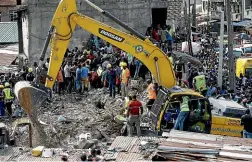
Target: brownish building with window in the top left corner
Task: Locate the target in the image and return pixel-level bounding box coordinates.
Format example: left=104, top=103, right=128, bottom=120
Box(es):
left=0, top=0, right=17, bottom=22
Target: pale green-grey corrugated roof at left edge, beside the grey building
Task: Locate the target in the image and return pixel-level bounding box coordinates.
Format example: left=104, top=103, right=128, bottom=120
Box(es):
left=0, top=22, right=18, bottom=43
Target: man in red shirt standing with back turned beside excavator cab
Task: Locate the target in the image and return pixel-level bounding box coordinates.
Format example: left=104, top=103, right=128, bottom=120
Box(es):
left=127, top=95, right=143, bottom=137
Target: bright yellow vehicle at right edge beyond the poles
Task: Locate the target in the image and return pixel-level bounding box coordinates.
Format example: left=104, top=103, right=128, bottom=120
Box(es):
left=236, top=58, right=252, bottom=77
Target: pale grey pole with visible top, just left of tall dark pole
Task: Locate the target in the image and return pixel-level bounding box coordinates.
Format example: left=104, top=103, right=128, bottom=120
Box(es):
left=218, top=11, right=224, bottom=87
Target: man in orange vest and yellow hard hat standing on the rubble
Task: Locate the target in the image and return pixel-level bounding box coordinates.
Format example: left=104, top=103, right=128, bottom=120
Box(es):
left=121, top=62, right=130, bottom=97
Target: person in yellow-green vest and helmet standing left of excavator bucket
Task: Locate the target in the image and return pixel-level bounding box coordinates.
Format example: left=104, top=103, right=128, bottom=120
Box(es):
left=3, top=82, right=14, bottom=117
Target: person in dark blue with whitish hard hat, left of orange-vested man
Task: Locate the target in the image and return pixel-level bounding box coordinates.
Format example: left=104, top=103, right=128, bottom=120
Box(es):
left=106, top=64, right=116, bottom=98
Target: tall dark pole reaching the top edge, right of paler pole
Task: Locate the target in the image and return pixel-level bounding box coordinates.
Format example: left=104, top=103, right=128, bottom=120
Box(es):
left=226, top=0, right=235, bottom=90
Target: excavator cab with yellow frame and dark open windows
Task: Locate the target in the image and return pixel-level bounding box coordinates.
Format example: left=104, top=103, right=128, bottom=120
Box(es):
left=150, top=87, right=211, bottom=134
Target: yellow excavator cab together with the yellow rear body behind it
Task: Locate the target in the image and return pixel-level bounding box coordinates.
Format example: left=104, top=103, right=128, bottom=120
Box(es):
left=150, top=87, right=243, bottom=137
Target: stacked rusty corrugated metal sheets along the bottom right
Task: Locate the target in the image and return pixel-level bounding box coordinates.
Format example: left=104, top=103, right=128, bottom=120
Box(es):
left=104, top=131, right=252, bottom=161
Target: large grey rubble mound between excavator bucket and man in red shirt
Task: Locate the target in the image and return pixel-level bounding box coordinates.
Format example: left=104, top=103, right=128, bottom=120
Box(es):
left=39, top=89, right=123, bottom=147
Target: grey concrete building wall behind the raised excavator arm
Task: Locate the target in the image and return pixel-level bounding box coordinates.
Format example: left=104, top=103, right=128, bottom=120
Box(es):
left=22, top=0, right=182, bottom=62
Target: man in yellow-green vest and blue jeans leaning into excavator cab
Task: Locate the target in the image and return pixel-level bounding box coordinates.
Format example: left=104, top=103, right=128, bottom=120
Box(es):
left=174, top=96, right=189, bottom=131
